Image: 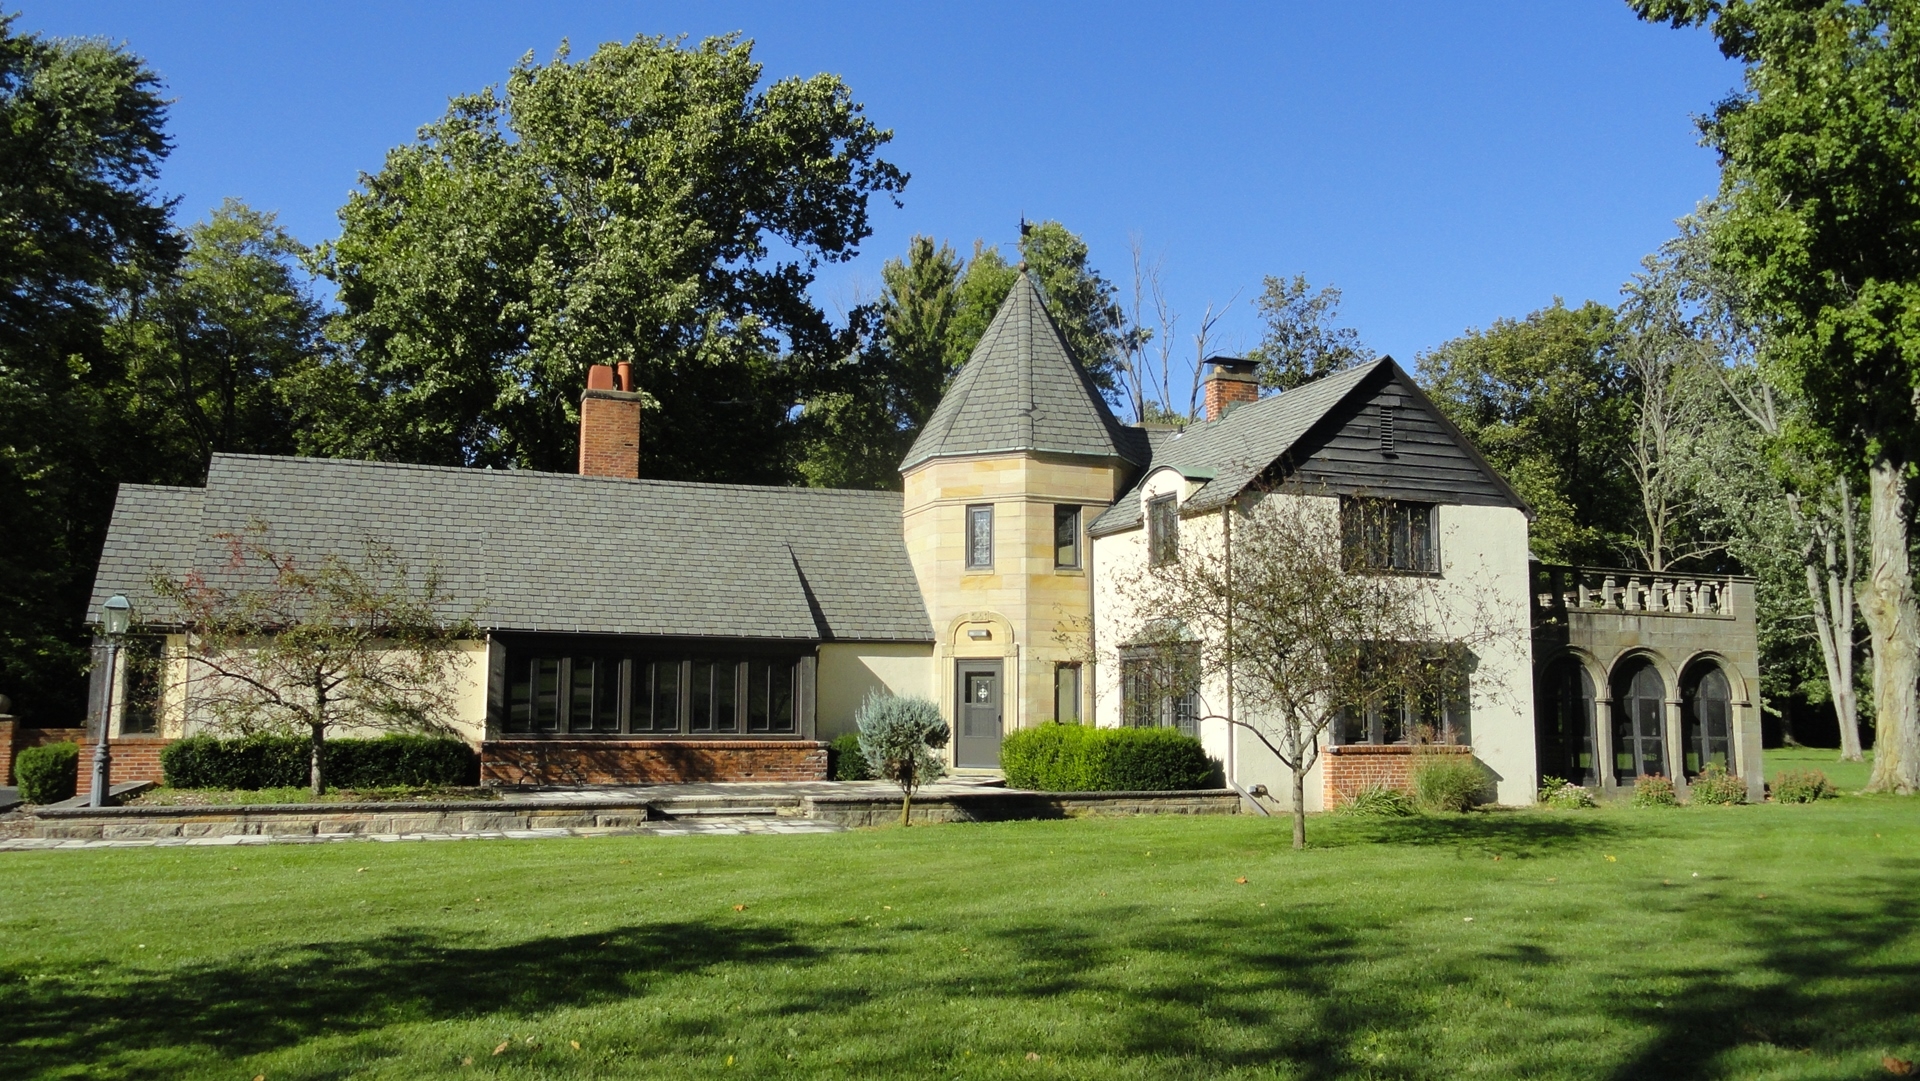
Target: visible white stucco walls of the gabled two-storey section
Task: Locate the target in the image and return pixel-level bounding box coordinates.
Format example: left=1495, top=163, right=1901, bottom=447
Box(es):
left=1092, top=491, right=1538, bottom=810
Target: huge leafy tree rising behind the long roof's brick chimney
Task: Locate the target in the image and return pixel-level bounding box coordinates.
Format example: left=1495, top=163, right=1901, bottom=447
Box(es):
left=301, top=36, right=906, bottom=482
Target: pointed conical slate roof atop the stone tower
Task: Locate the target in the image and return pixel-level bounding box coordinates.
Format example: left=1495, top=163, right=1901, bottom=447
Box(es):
left=900, top=271, right=1146, bottom=470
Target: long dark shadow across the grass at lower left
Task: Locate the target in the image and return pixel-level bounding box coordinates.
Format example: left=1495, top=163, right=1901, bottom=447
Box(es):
left=0, top=922, right=814, bottom=1077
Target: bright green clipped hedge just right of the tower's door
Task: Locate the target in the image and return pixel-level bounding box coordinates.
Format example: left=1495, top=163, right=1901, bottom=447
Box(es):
left=1000, top=724, right=1215, bottom=791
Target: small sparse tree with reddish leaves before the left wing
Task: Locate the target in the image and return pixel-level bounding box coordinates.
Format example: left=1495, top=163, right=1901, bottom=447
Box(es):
left=152, top=524, right=480, bottom=797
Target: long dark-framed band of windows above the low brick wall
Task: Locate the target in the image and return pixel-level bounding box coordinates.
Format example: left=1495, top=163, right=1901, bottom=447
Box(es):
left=497, top=649, right=801, bottom=735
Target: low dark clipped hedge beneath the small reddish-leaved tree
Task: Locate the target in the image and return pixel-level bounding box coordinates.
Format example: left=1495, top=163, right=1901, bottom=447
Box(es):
left=159, top=735, right=480, bottom=789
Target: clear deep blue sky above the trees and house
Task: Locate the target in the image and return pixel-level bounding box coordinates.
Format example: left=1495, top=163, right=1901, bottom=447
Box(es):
left=30, top=0, right=1740, bottom=391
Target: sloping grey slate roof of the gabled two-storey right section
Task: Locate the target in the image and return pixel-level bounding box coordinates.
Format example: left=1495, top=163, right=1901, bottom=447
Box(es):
left=1089, top=357, right=1400, bottom=536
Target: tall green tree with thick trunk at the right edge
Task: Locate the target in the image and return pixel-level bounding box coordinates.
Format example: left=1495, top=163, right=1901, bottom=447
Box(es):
left=1632, top=0, right=1920, bottom=793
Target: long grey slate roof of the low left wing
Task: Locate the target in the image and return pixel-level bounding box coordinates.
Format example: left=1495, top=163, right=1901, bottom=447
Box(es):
left=88, top=455, right=933, bottom=641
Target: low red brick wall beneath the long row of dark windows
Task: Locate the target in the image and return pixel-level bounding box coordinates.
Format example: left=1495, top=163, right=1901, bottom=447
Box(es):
left=480, top=739, right=828, bottom=785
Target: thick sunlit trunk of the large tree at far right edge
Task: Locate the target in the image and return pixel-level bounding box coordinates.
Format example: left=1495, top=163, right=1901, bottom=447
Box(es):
left=1860, top=457, right=1920, bottom=795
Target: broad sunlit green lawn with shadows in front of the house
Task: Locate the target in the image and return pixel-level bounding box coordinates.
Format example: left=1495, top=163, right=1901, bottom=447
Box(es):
left=0, top=797, right=1920, bottom=1081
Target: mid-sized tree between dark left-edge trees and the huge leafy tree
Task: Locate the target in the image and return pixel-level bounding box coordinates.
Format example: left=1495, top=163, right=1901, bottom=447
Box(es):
left=115, top=200, right=324, bottom=470
